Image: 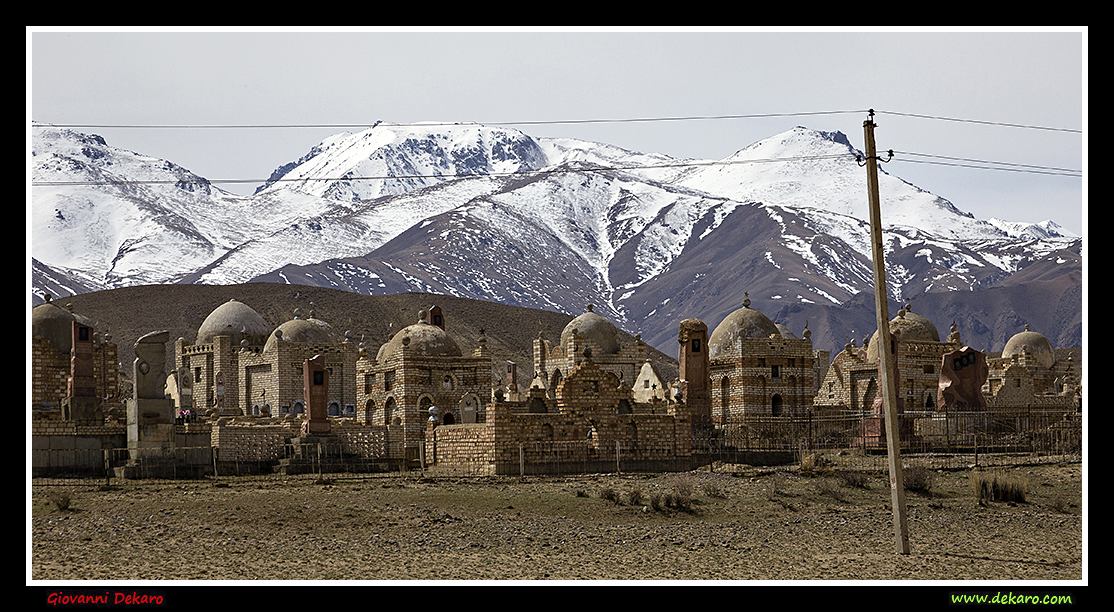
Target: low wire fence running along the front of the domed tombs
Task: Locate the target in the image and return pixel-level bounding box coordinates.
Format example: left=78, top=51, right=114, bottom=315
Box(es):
left=32, top=408, right=1083, bottom=487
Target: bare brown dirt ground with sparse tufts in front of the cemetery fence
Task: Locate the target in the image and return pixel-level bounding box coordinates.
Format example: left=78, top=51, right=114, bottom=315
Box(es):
left=29, top=463, right=1084, bottom=581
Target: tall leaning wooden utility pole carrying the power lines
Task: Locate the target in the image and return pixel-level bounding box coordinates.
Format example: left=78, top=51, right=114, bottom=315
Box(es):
left=862, top=109, right=909, bottom=554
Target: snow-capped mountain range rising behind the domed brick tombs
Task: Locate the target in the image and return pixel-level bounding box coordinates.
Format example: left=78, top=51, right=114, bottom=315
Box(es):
left=31, top=124, right=1082, bottom=350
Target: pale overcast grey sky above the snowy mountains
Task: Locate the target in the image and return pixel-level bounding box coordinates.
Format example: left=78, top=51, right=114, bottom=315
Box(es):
left=27, top=28, right=1087, bottom=234
